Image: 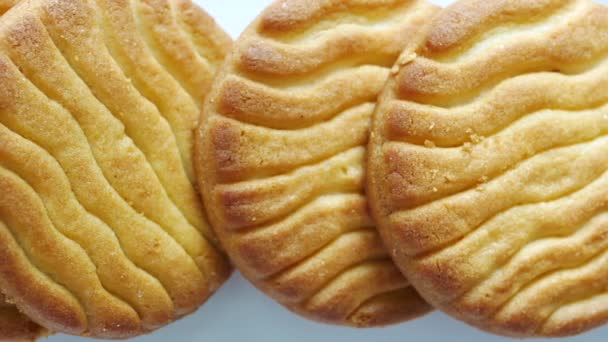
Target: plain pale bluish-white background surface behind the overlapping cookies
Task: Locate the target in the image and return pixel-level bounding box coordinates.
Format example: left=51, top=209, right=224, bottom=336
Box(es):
left=48, top=0, right=608, bottom=342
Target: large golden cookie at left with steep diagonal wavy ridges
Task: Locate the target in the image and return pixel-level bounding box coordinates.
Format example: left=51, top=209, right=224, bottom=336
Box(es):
left=0, top=0, right=230, bottom=338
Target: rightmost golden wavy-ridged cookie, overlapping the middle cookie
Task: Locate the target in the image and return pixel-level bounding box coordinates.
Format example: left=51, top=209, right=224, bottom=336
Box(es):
left=369, top=0, right=608, bottom=336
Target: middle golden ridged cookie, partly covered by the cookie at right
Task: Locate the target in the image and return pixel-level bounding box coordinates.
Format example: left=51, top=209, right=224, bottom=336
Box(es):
left=195, top=0, right=436, bottom=326
